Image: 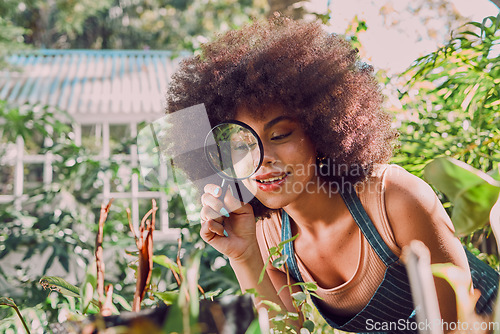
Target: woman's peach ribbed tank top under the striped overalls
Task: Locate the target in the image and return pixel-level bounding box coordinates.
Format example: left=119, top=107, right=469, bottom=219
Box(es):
left=257, top=165, right=401, bottom=316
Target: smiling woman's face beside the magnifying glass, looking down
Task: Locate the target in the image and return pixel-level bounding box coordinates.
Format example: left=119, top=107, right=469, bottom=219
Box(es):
left=236, top=106, right=317, bottom=209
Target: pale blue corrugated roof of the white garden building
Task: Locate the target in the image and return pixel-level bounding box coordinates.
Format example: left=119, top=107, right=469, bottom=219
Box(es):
left=0, top=50, right=188, bottom=123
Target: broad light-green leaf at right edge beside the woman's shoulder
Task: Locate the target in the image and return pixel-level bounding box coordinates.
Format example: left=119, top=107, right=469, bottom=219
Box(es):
left=424, top=157, right=500, bottom=236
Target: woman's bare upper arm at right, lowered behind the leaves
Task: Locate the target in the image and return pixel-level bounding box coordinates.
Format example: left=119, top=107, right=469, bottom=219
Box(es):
left=385, top=167, right=471, bottom=323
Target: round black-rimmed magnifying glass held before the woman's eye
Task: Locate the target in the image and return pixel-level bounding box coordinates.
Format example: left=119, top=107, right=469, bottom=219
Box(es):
left=205, top=121, right=264, bottom=201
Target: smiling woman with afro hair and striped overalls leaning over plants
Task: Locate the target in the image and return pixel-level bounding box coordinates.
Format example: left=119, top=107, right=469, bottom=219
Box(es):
left=168, top=16, right=498, bottom=332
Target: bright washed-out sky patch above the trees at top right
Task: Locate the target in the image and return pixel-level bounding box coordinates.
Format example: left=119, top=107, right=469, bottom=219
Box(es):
left=306, top=0, right=499, bottom=74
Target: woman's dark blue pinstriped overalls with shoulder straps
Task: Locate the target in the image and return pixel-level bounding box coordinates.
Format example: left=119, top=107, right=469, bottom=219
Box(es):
left=281, top=185, right=499, bottom=334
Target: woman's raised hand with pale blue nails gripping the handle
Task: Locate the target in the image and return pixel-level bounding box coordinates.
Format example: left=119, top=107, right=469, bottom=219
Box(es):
left=200, top=184, right=260, bottom=261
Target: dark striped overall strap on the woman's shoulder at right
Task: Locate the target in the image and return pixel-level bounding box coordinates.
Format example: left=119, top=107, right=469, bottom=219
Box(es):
left=340, top=183, right=399, bottom=266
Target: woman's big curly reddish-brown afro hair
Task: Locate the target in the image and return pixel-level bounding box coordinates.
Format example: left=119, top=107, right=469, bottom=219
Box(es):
left=167, top=15, right=397, bottom=216
